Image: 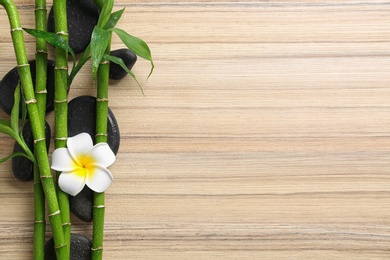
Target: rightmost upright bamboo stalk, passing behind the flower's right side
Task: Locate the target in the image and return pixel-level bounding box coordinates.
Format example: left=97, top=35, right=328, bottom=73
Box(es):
left=91, top=37, right=111, bottom=260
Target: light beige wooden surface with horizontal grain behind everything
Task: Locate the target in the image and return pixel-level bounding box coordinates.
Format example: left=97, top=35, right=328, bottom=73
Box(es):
left=0, top=0, right=390, bottom=260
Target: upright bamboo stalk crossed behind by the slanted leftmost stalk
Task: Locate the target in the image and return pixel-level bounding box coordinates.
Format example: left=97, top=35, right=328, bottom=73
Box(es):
left=34, top=0, right=47, bottom=260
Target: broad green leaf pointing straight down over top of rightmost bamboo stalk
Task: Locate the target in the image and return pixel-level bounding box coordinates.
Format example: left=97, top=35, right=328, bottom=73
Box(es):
left=91, top=26, right=111, bottom=78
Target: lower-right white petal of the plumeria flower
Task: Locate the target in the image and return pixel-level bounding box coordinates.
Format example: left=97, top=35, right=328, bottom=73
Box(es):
left=85, top=165, right=114, bottom=192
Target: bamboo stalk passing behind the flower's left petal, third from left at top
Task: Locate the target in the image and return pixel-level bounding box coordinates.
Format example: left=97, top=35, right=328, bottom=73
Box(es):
left=53, top=0, right=71, bottom=253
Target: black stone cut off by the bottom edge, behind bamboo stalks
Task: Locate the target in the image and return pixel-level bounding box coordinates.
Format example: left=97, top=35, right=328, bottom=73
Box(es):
left=45, top=233, right=92, bottom=260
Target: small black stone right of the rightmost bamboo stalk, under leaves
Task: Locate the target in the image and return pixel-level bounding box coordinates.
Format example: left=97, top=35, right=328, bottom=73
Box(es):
left=109, top=49, right=137, bottom=80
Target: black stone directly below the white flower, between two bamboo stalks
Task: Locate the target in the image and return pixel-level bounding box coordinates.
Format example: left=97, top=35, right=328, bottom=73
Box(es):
left=69, top=186, right=93, bottom=222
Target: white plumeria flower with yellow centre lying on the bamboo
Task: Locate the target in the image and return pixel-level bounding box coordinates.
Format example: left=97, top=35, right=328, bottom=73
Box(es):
left=51, top=133, right=115, bottom=196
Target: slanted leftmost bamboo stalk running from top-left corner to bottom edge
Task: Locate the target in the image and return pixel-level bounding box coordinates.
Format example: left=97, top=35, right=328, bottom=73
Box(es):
left=0, top=0, right=69, bottom=260
